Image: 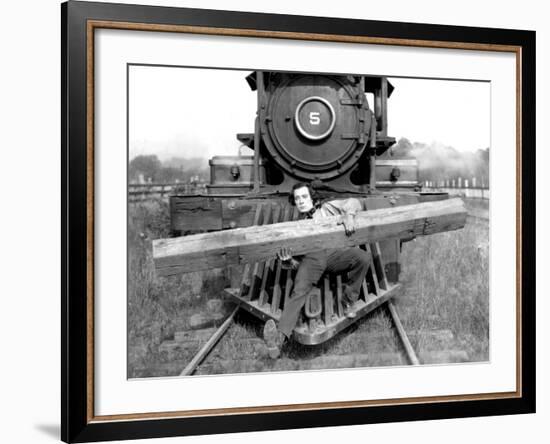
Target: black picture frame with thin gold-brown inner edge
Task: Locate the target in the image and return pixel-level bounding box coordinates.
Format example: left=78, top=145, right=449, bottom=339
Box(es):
left=61, top=1, right=536, bottom=442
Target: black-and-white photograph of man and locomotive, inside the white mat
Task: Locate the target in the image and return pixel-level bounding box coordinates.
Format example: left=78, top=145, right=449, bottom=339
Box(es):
left=127, top=64, right=492, bottom=379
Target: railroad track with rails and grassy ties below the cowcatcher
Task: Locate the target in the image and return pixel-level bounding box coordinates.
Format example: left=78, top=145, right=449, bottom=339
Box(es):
left=138, top=294, right=468, bottom=376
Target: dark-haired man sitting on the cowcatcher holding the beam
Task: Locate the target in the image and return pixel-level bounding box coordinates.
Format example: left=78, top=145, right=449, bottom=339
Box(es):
left=264, top=183, right=371, bottom=358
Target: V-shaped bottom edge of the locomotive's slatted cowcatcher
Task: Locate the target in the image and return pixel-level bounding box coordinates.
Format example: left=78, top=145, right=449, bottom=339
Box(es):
left=225, top=284, right=401, bottom=345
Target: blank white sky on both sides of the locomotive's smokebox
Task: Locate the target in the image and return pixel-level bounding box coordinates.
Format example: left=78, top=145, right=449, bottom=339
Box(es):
left=129, top=66, right=490, bottom=160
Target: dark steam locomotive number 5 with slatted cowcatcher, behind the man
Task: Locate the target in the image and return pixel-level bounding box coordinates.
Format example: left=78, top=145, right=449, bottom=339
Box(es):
left=170, top=71, right=447, bottom=344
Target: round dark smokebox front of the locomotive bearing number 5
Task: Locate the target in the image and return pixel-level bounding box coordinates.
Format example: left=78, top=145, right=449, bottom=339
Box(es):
left=260, top=75, right=372, bottom=181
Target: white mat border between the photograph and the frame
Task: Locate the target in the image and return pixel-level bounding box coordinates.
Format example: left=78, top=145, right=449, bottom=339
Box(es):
left=94, top=30, right=516, bottom=415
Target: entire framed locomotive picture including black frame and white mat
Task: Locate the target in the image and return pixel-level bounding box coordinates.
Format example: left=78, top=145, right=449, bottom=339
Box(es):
left=61, top=1, right=535, bottom=442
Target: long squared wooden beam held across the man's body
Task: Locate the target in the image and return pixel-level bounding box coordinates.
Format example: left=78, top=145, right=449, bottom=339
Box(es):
left=153, top=198, right=467, bottom=276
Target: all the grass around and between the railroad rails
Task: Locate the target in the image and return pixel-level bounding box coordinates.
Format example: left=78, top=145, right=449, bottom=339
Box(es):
left=128, top=200, right=489, bottom=378
